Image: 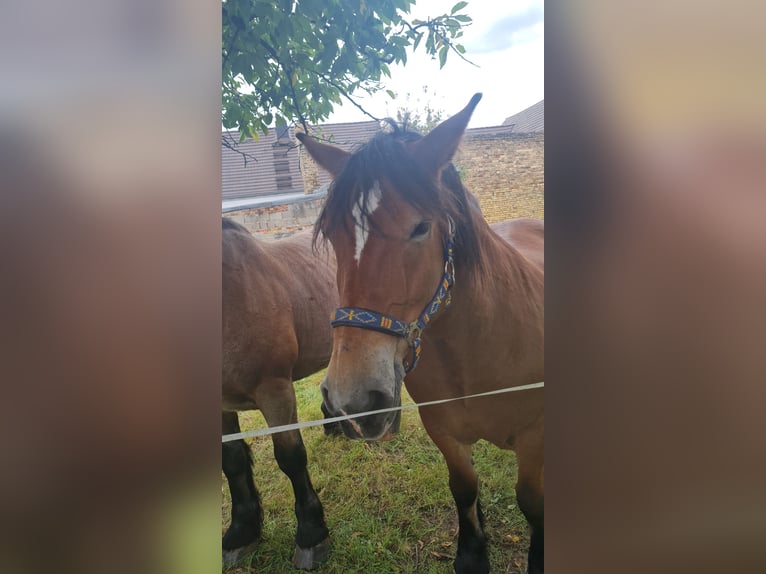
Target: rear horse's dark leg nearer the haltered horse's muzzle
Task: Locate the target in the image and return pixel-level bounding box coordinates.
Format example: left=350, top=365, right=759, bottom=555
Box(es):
left=256, top=379, right=330, bottom=570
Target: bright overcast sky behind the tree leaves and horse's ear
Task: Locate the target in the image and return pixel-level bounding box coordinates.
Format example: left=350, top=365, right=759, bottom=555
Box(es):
left=328, top=0, right=544, bottom=128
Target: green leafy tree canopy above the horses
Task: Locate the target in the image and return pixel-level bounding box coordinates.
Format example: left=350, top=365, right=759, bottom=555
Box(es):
left=222, top=0, right=471, bottom=139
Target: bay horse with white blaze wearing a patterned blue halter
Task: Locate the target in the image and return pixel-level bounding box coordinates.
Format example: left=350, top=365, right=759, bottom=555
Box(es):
left=298, top=94, right=544, bottom=574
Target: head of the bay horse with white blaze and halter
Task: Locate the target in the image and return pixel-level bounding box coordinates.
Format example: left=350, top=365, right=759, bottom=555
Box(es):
left=298, top=94, right=481, bottom=439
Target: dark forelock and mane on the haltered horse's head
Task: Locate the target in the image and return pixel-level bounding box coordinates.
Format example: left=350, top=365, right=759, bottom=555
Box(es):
left=314, top=122, right=481, bottom=271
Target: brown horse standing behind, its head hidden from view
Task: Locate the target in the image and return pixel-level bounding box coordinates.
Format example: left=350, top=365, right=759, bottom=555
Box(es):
left=221, top=218, right=338, bottom=570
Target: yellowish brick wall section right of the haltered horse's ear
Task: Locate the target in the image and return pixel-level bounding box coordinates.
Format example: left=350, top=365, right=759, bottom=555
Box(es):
left=454, top=133, right=545, bottom=223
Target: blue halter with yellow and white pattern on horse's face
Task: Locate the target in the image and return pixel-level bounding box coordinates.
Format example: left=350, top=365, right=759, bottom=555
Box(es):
left=330, top=215, right=455, bottom=373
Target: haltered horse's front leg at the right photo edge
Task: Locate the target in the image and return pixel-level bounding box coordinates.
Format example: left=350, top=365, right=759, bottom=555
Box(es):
left=515, top=419, right=545, bottom=574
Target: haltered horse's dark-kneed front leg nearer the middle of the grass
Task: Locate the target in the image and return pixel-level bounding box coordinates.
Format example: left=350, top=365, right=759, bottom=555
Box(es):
left=429, top=433, right=489, bottom=574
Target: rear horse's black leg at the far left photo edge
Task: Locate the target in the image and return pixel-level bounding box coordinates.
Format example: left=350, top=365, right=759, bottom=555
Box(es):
left=221, top=412, right=263, bottom=564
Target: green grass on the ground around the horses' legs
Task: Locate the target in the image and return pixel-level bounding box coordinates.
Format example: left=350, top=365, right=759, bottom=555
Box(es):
left=222, top=373, right=529, bottom=574
